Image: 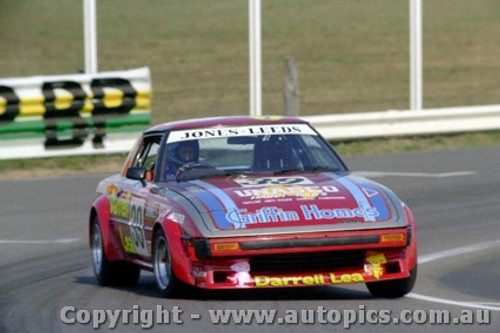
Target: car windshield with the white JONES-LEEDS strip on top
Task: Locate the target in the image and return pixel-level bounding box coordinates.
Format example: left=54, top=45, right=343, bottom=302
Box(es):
left=162, top=124, right=345, bottom=181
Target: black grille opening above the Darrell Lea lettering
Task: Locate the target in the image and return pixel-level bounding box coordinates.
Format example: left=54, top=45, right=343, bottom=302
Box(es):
left=250, top=250, right=366, bottom=272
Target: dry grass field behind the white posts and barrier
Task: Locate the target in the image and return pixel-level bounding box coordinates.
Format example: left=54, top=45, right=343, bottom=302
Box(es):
left=0, top=0, right=500, bottom=123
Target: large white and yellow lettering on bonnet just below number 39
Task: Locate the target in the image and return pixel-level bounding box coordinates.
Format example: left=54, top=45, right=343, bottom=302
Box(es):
left=234, top=185, right=339, bottom=200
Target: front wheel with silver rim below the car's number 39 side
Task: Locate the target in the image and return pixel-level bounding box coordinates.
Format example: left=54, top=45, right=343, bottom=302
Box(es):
left=153, top=228, right=182, bottom=297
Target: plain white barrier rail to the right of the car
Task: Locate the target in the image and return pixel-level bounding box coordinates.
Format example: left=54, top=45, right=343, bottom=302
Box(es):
left=302, top=105, right=500, bottom=140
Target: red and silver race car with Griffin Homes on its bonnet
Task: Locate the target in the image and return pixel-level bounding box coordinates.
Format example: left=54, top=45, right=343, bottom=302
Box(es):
left=88, top=117, right=417, bottom=298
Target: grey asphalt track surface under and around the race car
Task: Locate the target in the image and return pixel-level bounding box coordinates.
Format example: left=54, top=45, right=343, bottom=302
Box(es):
left=0, top=148, right=500, bottom=332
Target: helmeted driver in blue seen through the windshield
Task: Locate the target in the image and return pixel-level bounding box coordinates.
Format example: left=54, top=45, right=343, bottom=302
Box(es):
left=165, top=140, right=199, bottom=177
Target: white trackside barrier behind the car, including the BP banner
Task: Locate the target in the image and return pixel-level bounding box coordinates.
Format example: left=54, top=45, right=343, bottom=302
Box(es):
left=0, top=68, right=500, bottom=160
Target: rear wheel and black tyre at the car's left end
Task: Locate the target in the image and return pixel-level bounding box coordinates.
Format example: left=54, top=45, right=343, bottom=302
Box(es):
left=91, top=217, right=141, bottom=286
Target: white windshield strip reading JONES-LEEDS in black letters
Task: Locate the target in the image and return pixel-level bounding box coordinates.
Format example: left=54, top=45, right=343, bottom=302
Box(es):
left=167, top=124, right=317, bottom=143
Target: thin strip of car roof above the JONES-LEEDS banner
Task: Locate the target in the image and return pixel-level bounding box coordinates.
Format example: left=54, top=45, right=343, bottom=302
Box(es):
left=144, top=116, right=308, bottom=134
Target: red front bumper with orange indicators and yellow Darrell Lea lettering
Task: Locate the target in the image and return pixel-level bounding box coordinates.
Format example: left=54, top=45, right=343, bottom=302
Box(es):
left=184, top=228, right=413, bottom=289
